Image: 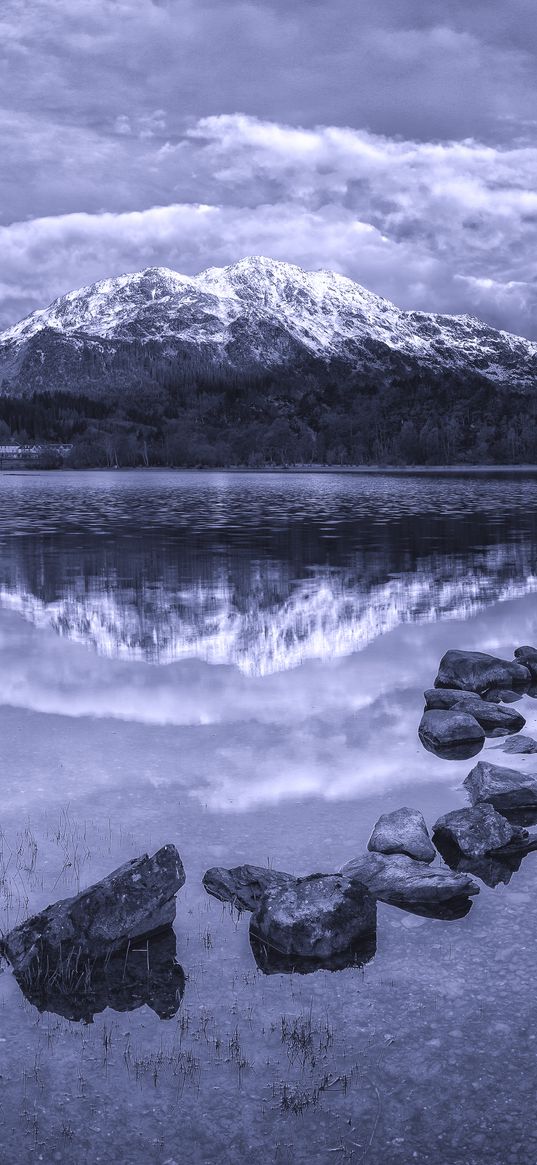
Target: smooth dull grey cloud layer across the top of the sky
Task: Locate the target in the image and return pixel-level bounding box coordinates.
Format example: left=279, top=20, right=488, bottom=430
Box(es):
left=2, top=0, right=537, bottom=149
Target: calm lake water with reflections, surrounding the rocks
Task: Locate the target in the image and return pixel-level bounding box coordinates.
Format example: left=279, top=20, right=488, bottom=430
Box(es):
left=0, top=471, right=537, bottom=1165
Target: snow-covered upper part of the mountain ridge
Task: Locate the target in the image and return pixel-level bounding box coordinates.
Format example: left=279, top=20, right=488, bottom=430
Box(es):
left=0, top=256, right=537, bottom=388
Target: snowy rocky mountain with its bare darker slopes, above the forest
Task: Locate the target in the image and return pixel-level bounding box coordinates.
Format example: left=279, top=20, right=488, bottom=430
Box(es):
left=0, top=257, right=537, bottom=397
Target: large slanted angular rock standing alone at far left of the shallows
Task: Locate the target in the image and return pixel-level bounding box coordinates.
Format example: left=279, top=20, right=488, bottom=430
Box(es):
left=1, top=846, right=185, bottom=974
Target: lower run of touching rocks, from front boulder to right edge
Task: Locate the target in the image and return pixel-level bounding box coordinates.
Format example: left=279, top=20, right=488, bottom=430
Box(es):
left=203, top=762, right=537, bottom=974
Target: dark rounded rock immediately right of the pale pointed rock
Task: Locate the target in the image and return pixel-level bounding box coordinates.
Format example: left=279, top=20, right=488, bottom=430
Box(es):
left=433, top=803, right=528, bottom=857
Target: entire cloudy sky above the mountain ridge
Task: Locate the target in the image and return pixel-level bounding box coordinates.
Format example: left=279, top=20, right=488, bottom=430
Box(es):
left=0, top=0, right=537, bottom=338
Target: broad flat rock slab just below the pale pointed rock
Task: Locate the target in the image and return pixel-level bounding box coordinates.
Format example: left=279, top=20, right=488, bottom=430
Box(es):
left=341, top=853, right=479, bottom=918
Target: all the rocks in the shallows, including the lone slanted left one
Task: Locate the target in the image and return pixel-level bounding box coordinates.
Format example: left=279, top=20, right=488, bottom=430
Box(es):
left=6, top=648, right=537, bottom=1022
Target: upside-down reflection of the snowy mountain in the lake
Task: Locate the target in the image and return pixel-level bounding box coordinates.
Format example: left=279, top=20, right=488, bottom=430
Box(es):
left=0, top=542, right=537, bottom=676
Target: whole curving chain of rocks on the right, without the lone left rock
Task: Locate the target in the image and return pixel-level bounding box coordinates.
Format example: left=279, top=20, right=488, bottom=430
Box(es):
left=199, top=648, right=537, bottom=972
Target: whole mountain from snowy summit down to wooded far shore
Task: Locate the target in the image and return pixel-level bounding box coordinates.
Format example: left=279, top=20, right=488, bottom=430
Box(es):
left=0, top=257, right=537, bottom=464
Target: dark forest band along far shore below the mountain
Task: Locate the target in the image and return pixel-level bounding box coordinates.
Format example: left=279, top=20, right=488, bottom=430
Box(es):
left=0, top=351, right=537, bottom=468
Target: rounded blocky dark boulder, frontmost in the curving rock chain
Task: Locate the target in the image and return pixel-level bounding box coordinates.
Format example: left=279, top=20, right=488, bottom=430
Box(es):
left=249, top=874, right=376, bottom=970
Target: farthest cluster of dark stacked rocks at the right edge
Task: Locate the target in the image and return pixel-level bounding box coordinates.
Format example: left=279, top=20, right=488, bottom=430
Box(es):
left=418, top=647, right=537, bottom=760
